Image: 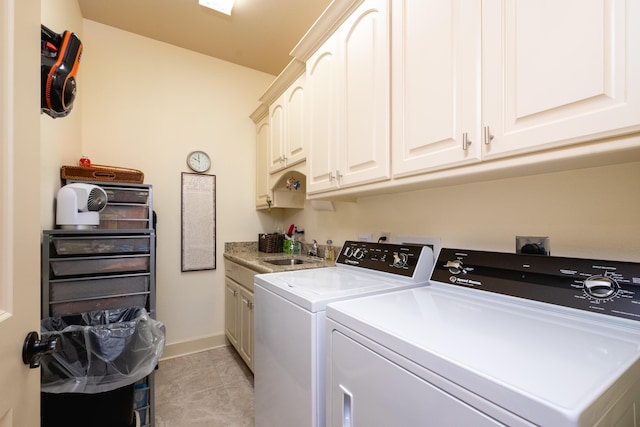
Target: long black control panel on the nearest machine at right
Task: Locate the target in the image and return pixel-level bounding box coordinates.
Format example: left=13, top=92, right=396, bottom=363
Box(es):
left=431, top=249, right=640, bottom=320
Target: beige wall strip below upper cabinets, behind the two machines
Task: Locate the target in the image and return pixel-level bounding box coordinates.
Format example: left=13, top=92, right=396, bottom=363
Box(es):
left=278, top=159, right=640, bottom=262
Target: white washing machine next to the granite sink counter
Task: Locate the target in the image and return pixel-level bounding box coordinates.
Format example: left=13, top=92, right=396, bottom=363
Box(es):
left=254, top=241, right=434, bottom=427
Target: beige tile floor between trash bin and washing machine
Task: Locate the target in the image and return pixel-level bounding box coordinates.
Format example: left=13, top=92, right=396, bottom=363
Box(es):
left=155, top=347, right=254, bottom=427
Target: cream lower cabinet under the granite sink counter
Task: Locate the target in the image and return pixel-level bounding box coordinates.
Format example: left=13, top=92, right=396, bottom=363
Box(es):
left=224, top=260, right=257, bottom=371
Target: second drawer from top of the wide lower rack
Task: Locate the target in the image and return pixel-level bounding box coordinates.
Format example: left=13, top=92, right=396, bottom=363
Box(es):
left=49, top=255, right=149, bottom=277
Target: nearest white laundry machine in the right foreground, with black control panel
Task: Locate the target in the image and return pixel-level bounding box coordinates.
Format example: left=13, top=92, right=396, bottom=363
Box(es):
left=326, top=249, right=640, bottom=427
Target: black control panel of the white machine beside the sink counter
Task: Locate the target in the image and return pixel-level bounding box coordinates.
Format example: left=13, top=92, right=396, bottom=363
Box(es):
left=336, top=241, right=433, bottom=281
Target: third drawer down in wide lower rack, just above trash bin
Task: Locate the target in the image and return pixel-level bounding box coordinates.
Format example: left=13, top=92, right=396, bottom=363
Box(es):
left=49, top=275, right=150, bottom=303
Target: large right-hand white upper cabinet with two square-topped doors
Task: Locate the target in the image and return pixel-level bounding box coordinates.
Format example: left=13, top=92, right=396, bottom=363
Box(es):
left=392, top=0, right=640, bottom=177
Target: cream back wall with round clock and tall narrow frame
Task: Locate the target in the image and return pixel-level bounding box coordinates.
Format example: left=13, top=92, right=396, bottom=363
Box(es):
left=76, top=20, right=274, bottom=351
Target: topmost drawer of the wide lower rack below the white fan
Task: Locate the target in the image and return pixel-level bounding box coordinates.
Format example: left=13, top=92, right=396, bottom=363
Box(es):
left=51, top=236, right=151, bottom=255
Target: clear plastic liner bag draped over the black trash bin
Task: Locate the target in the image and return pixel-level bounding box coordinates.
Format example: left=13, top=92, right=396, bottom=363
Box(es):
left=41, top=307, right=165, bottom=393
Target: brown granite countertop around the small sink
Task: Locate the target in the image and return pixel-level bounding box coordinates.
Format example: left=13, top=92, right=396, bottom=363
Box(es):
left=224, top=242, right=335, bottom=273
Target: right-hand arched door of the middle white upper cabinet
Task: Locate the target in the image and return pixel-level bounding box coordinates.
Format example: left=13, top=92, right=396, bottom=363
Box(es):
left=336, top=0, right=390, bottom=186
